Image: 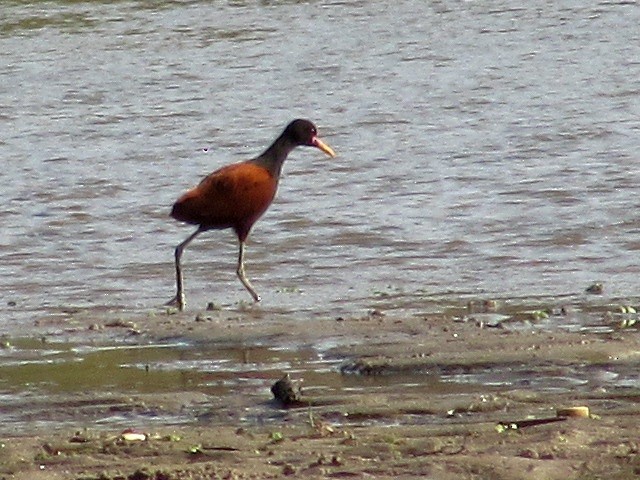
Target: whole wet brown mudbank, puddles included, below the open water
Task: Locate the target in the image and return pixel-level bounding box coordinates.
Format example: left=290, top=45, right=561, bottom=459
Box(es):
left=0, top=302, right=640, bottom=479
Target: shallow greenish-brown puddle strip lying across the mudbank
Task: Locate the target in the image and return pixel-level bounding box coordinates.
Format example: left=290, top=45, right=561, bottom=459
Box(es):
left=0, top=339, right=639, bottom=434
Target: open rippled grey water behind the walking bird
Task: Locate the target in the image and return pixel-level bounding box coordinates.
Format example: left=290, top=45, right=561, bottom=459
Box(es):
left=0, top=0, right=640, bottom=322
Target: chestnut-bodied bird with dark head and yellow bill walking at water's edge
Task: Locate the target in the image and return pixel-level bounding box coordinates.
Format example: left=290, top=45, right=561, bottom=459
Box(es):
left=167, top=118, right=336, bottom=311
